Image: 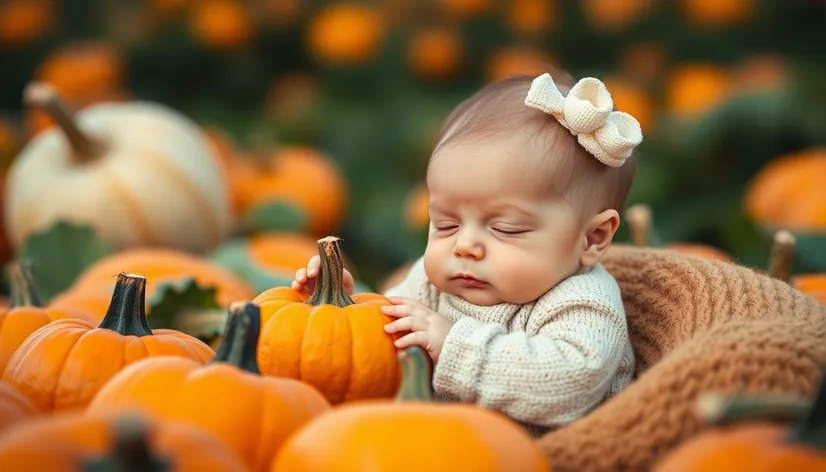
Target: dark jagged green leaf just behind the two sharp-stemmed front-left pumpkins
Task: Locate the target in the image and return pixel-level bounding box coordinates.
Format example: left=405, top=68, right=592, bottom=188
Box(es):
left=147, top=277, right=221, bottom=338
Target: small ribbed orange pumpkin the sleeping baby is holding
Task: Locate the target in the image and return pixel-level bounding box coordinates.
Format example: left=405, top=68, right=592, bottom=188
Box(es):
left=253, top=236, right=400, bottom=405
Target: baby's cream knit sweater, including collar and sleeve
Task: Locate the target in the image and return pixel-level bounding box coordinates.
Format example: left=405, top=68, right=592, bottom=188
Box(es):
left=385, top=259, right=634, bottom=436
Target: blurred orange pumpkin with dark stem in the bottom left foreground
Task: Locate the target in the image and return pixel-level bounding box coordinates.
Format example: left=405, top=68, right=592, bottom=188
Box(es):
left=0, top=414, right=249, bottom=472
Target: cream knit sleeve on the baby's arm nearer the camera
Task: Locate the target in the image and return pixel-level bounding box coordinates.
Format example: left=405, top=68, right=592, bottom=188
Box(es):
left=433, top=270, right=628, bottom=428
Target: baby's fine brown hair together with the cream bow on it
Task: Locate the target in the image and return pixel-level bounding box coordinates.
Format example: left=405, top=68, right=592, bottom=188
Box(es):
left=433, top=70, right=642, bottom=213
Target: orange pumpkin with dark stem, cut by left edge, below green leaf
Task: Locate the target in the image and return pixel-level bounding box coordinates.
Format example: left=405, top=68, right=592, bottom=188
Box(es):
left=0, top=263, right=98, bottom=373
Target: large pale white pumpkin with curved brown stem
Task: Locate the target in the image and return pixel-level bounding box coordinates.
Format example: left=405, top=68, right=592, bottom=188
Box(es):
left=5, top=83, right=231, bottom=252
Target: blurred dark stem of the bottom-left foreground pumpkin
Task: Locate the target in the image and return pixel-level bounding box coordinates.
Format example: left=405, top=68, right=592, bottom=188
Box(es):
left=84, top=415, right=171, bottom=472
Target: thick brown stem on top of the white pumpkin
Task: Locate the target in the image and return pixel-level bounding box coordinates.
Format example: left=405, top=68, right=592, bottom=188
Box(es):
left=23, top=82, right=104, bottom=164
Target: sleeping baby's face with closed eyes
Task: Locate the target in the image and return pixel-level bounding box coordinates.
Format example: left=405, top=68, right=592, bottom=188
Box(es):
left=424, top=132, right=586, bottom=305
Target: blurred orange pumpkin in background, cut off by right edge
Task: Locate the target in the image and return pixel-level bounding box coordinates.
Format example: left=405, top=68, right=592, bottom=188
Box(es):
left=744, top=147, right=826, bottom=232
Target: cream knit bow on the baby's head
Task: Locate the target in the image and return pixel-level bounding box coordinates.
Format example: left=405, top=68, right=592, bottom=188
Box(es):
left=525, top=73, right=642, bottom=167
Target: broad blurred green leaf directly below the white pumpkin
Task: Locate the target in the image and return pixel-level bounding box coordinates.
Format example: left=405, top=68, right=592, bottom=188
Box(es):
left=17, top=221, right=115, bottom=302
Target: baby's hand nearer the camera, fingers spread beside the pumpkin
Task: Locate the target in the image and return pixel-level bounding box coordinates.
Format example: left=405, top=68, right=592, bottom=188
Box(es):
left=381, top=297, right=453, bottom=364
